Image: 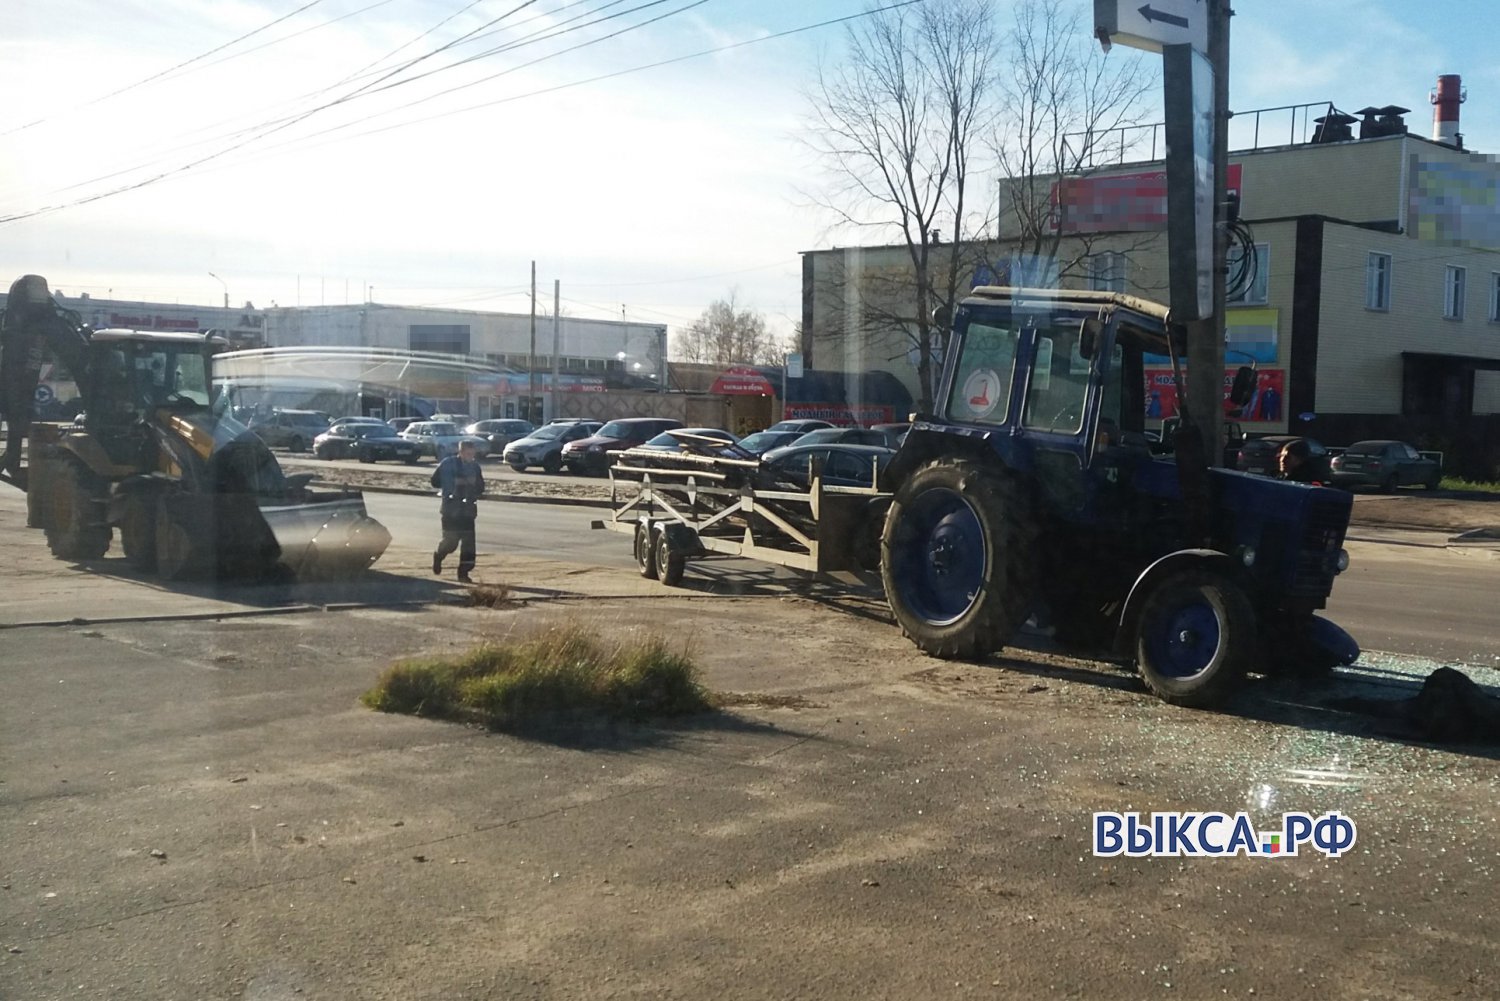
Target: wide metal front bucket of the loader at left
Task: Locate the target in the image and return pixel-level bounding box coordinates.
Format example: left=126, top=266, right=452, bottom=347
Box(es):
left=260, top=495, right=390, bottom=579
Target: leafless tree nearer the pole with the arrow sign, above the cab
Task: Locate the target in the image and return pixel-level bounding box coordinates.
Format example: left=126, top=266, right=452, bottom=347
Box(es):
left=992, top=0, right=1157, bottom=281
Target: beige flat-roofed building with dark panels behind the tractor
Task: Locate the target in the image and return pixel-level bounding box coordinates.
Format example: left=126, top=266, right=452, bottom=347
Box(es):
left=803, top=117, right=1500, bottom=476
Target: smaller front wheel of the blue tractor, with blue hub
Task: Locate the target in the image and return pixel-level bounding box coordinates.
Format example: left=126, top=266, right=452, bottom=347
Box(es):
left=1136, top=570, right=1259, bottom=708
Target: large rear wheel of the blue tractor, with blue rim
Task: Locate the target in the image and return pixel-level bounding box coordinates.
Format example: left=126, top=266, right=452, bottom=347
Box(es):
left=881, top=459, right=1037, bottom=659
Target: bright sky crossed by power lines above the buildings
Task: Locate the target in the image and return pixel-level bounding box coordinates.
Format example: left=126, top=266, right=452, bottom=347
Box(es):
left=0, top=0, right=1500, bottom=336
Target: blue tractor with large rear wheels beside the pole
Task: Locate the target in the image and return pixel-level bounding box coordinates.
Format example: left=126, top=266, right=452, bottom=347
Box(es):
left=881, top=288, right=1359, bottom=707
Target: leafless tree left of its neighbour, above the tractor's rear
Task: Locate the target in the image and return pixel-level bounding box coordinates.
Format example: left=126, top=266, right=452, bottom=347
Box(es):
left=807, top=0, right=996, bottom=410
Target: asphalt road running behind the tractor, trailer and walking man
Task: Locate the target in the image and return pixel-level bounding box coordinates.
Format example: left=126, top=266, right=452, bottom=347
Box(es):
left=365, top=492, right=1500, bottom=666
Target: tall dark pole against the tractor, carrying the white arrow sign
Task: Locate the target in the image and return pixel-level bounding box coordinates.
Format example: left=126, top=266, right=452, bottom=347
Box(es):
left=1188, top=0, right=1232, bottom=465
